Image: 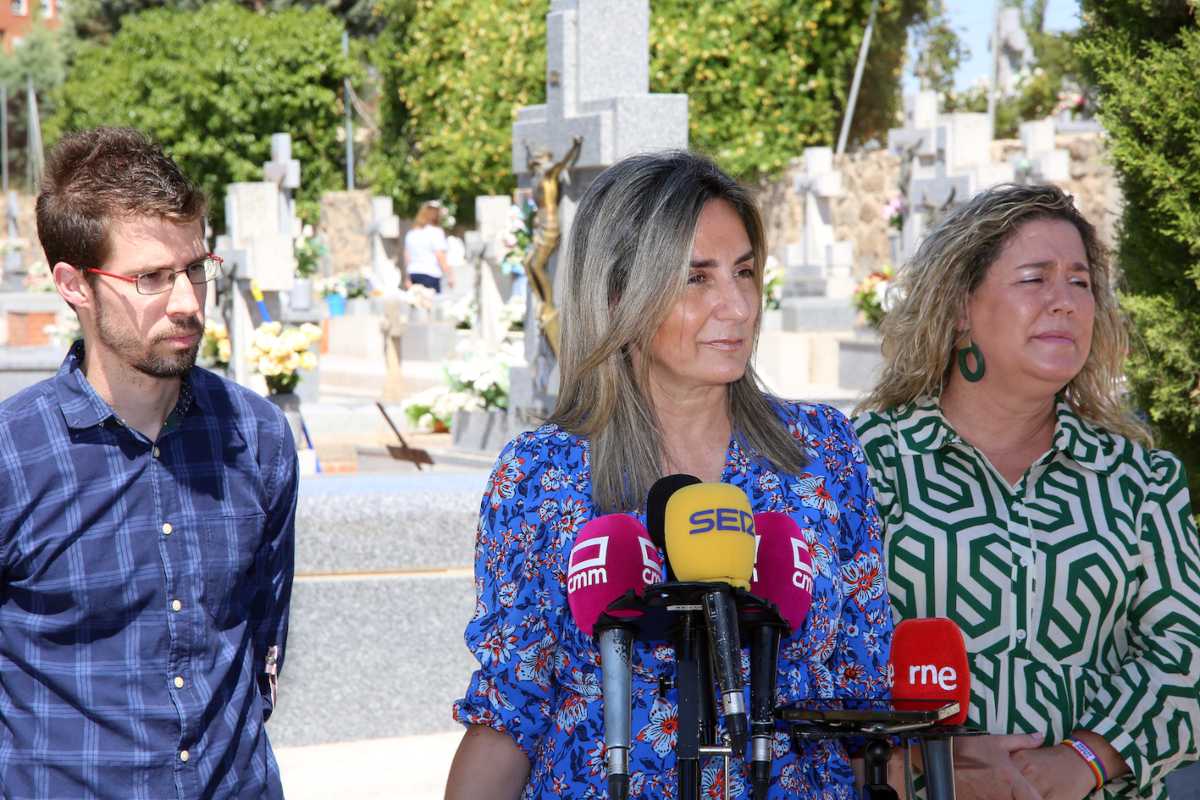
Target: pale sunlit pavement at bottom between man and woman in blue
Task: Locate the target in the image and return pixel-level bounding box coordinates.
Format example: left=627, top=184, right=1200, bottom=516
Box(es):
left=277, top=723, right=462, bottom=800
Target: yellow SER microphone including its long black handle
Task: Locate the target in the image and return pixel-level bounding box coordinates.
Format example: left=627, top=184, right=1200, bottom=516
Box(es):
left=664, top=483, right=755, bottom=754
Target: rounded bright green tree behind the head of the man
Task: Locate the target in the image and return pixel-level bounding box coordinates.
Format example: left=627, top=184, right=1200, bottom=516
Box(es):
left=46, top=2, right=353, bottom=227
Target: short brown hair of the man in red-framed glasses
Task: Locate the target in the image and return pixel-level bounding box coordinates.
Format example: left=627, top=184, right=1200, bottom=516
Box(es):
left=37, top=127, right=206, bottom=269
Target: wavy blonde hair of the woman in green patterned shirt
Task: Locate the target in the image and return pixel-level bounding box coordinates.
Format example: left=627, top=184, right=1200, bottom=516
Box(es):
left=856, top=184, right=1152, bottom=446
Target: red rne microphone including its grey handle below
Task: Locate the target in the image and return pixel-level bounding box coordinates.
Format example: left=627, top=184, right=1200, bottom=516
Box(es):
left=892, top=616, right=971, bottom=800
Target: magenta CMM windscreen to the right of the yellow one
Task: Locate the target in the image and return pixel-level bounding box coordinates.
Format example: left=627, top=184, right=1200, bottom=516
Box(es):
left=750, top=511, right=812, bottom=632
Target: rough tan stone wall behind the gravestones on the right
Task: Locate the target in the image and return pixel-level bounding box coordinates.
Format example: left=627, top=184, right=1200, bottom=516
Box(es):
left=755, top=133, right=1122, bottom=278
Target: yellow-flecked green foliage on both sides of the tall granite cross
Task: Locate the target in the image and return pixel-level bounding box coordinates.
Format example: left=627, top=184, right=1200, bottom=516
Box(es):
left=367, top=0, right=929, bottom=219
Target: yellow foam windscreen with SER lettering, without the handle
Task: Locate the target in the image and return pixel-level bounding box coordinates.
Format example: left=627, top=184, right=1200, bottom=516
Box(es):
left=666, top=483, right=755, bottom=589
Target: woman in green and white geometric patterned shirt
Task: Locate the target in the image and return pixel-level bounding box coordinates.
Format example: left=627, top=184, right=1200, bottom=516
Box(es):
left=856, top=186, right=1200, bottom=800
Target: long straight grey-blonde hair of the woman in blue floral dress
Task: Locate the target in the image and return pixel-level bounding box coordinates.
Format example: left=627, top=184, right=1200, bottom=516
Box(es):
left=548, top=150, right=805, bottom=511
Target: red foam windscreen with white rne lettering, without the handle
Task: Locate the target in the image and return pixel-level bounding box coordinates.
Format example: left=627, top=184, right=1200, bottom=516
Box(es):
left=892, top=616, right=971, bottom=724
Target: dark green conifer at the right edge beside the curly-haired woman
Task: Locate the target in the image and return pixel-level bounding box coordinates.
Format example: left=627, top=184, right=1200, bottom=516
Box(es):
left=1079, top=0, right=1200, bottom=507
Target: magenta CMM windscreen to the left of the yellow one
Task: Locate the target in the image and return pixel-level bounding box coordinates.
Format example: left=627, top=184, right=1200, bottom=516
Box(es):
left=566, top=513, right=662, bottom=636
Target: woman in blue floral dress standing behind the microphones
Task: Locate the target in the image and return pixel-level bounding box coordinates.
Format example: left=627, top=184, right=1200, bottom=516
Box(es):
left=446, top=152, right=892, bottom=800
